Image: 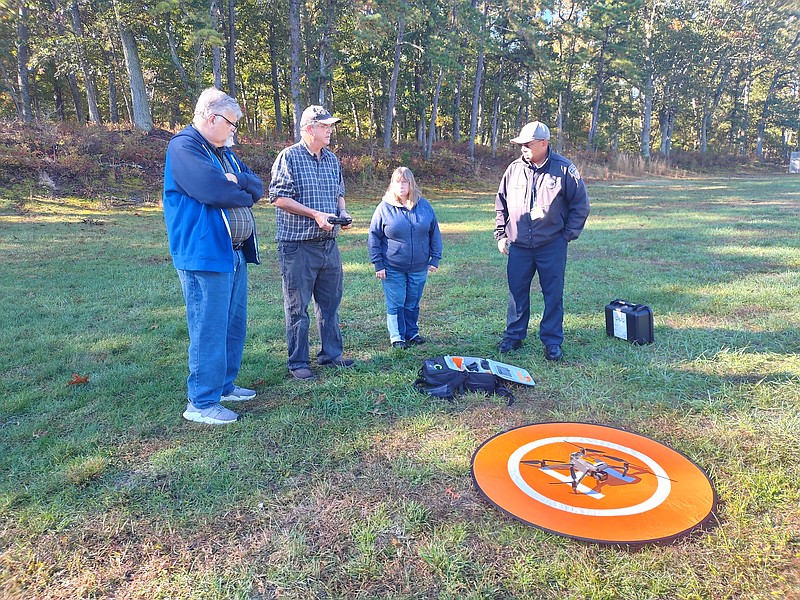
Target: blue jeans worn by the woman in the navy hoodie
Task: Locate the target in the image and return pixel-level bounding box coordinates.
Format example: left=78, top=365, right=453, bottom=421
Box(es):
left=381, top=267, right=428, bottom=342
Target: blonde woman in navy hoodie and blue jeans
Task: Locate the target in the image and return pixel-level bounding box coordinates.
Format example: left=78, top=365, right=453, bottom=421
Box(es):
left=369, top=167, right=442, bottom=348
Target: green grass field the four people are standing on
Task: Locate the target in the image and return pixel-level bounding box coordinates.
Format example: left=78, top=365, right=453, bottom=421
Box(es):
left=0, top=176, right=800, bottom=599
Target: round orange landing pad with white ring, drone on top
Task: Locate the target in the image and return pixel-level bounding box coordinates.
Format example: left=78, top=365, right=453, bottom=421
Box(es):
left=472, top=423, right=716, bottom=544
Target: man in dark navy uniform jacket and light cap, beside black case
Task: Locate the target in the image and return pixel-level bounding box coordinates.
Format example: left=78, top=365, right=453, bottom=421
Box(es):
left=494, top=121, right=589, bottom=361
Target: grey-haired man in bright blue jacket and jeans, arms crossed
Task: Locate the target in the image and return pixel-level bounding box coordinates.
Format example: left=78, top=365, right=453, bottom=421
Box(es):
left=164, top=87, right=264, bottom=425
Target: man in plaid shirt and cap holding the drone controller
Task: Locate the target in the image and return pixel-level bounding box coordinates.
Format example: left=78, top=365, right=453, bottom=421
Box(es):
left=269, top=106, right=354, bottom=380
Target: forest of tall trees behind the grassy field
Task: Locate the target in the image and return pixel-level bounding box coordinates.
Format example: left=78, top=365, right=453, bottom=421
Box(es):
left=0, top=0, right=800, bottom=177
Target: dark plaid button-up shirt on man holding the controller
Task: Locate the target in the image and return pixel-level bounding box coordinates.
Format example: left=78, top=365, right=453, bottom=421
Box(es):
left=269, top=141, right=344, bottom=242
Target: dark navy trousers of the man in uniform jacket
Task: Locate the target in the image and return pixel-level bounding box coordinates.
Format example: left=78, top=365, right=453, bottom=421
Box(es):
left=504, top=236, right=567, bottom=346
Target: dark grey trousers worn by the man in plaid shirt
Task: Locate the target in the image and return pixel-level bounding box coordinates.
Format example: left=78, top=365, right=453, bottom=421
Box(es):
left=278, top=238, right=344, bottom=371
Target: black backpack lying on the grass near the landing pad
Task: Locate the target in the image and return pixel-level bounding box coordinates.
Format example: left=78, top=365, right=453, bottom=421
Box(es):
left=414, top=356, right=515, bottom=406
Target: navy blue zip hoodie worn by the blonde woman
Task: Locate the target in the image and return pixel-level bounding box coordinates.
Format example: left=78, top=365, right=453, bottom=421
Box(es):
left=368, top=198, right=442, bottom=273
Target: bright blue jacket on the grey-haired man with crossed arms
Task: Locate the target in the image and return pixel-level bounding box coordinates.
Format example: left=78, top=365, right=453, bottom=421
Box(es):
left=163, top=125, right=264, bottom=273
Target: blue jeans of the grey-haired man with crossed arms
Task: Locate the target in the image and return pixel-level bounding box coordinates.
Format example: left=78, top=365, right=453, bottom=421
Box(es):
left=178, top=250, right=247, bottom=408
